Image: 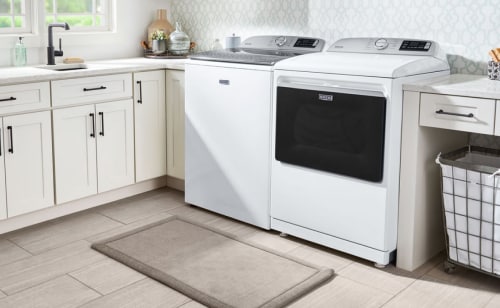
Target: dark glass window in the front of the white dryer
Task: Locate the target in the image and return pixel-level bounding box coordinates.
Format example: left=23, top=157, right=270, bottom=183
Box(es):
left=275, top=86, right=386, bottom=182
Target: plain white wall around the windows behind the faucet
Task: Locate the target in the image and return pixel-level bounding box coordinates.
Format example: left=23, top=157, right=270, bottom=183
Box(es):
left=0, top=0, right=168, bottom=66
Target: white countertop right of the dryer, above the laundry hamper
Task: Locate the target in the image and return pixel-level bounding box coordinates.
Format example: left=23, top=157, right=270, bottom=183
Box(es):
left=403, top=74, right=500, bottom=99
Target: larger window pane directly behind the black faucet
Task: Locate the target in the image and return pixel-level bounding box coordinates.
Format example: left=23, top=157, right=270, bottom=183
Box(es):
left=45, top=0, right=111, bottom=31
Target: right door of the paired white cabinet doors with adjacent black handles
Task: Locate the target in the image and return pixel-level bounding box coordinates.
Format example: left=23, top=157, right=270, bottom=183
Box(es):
left=96, top=99, right=134, bottom=193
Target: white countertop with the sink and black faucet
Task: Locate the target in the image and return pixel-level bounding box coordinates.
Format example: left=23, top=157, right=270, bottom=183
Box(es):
left=0, top=58, right=186, bottom=85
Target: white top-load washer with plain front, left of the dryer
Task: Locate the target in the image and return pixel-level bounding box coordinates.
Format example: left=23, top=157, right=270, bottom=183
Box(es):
left=185, top=36, right=324, bottom=229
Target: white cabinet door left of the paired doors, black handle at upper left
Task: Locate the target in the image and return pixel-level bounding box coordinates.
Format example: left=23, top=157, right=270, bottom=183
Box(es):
left=3, top=111, right=54, bottom=217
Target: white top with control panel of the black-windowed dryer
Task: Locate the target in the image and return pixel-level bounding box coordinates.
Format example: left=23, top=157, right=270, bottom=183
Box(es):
left=275, top=38, right=450, bottom=78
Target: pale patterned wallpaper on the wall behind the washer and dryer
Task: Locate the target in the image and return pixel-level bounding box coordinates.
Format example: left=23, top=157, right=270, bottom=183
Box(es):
left=165, top=0, right=500, bottom=74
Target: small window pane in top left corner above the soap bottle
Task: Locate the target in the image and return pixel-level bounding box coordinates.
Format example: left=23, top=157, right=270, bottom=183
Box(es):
left=0, top=0, right=32, bottom=33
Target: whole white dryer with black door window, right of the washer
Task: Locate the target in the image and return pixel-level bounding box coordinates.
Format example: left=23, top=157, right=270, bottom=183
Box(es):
left=271, top=38, right=449, bottom=265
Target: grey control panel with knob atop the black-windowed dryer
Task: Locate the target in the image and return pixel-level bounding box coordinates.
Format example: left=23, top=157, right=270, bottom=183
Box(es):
left=328, top=37, right=438, bottom=56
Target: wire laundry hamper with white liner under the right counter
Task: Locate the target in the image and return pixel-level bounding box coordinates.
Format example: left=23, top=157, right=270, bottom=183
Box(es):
left=436, top=146, right=500, bottom=277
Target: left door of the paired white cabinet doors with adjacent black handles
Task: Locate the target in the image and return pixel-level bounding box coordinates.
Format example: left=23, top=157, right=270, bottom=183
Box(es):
left=53, top=105, right=97, bottom=204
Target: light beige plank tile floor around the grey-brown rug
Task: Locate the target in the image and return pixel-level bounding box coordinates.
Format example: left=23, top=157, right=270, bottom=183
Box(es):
left=0, top=188, right=500, bottom=308
